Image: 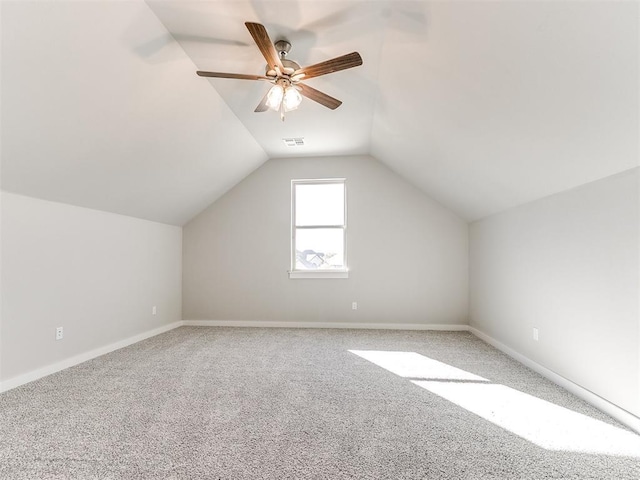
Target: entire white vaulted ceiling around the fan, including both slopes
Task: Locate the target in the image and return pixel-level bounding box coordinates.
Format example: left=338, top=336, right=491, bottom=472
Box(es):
left=1, top=0, right=640, bottom=225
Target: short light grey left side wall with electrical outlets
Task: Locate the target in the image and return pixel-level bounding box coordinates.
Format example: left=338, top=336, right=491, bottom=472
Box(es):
left=0, top=192, right=182, bottom=381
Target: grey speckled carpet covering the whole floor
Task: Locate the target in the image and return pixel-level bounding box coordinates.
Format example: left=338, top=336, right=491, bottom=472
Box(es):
left=0, top=327, right=640, bottom=480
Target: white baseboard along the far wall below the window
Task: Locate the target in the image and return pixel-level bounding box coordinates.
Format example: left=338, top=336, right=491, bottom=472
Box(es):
left=183, top=320, right=469, bottom=332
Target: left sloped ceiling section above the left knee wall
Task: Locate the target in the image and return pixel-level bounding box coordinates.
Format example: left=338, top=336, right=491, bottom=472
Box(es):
left=1, top=1, right=267, bottom=225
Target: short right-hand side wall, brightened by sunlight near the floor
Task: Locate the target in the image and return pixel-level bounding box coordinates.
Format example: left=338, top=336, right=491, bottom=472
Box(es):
left=470, top=168, right=640, bottom=415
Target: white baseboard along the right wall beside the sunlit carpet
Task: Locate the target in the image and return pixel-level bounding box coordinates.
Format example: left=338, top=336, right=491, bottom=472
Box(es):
left=468, top=326, right=640, bottom=433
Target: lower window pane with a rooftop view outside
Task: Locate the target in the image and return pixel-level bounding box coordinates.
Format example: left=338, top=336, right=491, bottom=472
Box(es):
left=296, top=228, right=344, bottom=270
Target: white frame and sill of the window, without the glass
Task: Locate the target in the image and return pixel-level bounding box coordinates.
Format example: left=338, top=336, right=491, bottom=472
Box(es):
left=289, top=178, right=349, bottom=279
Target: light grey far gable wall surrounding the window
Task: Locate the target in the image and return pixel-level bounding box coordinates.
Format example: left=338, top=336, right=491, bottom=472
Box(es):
left=183, top=156, right=468, bottom=324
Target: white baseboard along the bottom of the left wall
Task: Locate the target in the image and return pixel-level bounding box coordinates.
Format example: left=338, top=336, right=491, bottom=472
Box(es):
left=0, top=321, right=183, bottom=392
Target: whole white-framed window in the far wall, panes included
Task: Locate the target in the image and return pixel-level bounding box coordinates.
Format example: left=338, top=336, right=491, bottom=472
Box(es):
left=289, top=178, right=347, bottom=278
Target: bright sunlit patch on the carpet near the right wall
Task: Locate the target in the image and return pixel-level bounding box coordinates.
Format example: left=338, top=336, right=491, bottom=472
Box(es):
left=349, top=350, right=640, bottom=458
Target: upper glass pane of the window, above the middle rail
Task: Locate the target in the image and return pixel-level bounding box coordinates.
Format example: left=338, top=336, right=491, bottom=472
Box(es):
left=295, top=183, right=344, bottom=226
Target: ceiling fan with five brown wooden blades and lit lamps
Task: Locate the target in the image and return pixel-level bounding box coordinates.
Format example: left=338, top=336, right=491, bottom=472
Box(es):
left=196, top=22, right=362, bottom=121
